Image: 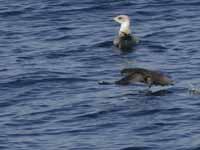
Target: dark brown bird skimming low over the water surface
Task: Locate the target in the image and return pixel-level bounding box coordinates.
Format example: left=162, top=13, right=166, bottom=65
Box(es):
left=115, top=68, right=173, bottom=87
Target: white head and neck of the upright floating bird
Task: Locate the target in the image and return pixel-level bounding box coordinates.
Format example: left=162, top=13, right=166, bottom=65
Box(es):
left=114, top=15, right=131, bottom=34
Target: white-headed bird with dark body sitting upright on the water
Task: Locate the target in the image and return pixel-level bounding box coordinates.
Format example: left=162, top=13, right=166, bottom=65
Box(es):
left=113, top=15, right=139, bottom=50
